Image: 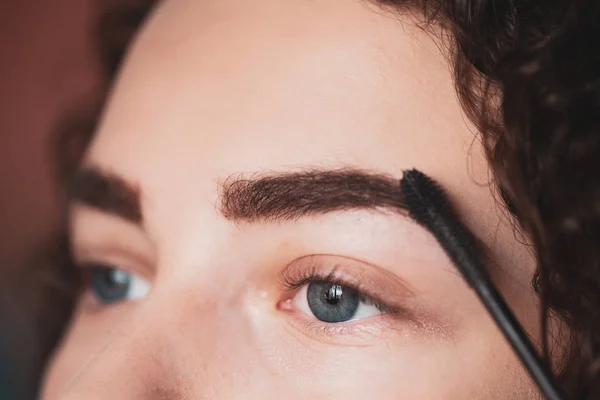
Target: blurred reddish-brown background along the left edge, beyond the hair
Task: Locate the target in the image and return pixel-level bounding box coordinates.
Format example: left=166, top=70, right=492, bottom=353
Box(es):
left=0, top=0, right=101, bottom=399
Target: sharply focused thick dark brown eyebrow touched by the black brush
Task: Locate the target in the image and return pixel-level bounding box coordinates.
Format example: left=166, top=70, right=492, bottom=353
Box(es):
left=220, top=169, right=405, bottom=222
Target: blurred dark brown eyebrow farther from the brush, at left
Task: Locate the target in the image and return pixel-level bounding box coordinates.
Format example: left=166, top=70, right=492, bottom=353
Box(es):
left=68, top=167, right=143, bottom=225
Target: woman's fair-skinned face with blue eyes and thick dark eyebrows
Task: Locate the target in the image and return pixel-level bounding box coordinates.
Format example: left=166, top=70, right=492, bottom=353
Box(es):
left=43, top=0, right=539, bottom=400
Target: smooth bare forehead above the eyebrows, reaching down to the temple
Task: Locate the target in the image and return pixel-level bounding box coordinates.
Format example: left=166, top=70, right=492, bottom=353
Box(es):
left=83, top=0, right=524, bottom=278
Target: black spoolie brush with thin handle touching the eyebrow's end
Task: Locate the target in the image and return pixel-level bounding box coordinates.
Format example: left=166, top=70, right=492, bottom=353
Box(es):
left=400, top=169, right=566, bottom=400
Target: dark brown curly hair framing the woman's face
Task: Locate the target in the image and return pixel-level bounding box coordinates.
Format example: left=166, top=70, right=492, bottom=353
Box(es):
left=38, top=0, right=600, bottom=398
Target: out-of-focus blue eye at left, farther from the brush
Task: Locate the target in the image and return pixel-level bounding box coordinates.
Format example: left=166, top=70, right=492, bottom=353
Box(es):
left=86, top=265, right=150, bottom=305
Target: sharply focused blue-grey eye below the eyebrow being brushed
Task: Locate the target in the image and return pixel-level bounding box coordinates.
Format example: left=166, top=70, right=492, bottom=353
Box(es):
left=294, top=281, right=383, bottom=323
